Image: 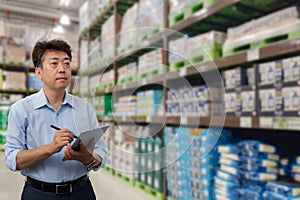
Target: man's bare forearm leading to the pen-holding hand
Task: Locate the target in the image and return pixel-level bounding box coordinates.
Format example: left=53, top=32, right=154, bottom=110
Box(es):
left=16, top=145, right=54, bottom=170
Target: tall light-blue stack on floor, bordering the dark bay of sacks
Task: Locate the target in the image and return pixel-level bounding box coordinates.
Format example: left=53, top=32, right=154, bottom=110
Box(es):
left=189, top=129, right=231, bottom=200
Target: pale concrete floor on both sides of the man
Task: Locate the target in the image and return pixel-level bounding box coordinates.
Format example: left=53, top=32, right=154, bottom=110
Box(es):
left=0, top=152, right=154, bottom=200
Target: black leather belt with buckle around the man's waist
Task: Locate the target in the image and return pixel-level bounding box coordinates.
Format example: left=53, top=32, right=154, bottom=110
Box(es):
left=26, top=175, right=89, bottom=194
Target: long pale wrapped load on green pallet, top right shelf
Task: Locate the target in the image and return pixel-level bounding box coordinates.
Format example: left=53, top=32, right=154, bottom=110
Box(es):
left=223, top=6, right=300, bottom=56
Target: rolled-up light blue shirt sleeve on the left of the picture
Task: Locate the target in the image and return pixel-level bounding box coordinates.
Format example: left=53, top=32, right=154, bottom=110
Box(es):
left=4, top=105, right=26, bottom=171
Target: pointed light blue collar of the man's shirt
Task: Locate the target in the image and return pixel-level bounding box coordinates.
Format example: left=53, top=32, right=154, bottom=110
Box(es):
left=33, top=88, right=73, bottom=109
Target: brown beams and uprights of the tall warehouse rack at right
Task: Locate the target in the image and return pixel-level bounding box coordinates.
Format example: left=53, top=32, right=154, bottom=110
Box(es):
left=80, top=0, right=300, bottom=198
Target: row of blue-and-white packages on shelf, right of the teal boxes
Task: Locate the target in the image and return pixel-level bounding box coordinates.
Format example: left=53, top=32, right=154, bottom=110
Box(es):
left=166, top=85, right=221, bottom=117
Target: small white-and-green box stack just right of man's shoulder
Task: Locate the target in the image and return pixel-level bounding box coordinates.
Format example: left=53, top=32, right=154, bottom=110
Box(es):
left=93, top=94, right=113, bottom=116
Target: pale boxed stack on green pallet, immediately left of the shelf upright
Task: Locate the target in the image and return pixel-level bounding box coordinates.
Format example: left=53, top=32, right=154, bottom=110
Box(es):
left=138, top=49, right=166, bottom=79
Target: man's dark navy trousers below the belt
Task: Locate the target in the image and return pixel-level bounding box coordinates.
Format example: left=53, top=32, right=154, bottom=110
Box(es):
left=22, top=180, right=96, bottom=200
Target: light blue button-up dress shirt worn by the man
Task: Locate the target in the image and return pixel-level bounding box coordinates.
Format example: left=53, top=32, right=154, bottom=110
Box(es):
left=4, top=89, right=107, bottom=182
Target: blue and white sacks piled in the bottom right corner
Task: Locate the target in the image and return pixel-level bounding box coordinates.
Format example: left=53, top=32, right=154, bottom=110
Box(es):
left=263, top=182, right=300, bottom=200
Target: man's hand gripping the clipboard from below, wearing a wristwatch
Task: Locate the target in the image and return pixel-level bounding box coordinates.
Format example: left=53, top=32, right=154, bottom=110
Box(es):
left=64, top=141, right=94, bottom=165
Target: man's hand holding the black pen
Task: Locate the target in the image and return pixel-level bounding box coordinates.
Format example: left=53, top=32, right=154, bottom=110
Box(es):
left=50, top=129, right=75, bottom=153
